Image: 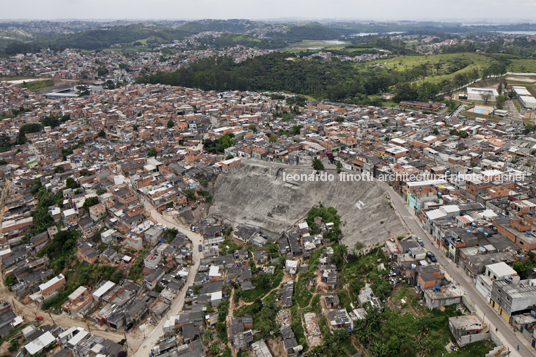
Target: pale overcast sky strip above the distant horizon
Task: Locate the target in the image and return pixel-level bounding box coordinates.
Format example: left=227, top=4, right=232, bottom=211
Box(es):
left=0, top=0, right=536, bottom=22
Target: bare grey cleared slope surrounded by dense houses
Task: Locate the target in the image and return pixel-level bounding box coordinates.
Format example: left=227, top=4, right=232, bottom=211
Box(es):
left=209, top=163, right=406, bottom=248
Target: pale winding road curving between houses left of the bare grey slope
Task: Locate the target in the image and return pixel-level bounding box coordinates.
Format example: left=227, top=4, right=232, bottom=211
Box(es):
left=134, top=202, right=203, bottom=357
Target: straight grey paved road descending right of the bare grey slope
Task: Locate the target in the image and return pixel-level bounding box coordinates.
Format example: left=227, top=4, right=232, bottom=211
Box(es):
left=376, top=181, right=536, bottom=357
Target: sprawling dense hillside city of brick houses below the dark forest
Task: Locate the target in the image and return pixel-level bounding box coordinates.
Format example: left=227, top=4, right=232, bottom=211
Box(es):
left=4, top=16, right=536, bottom=357
